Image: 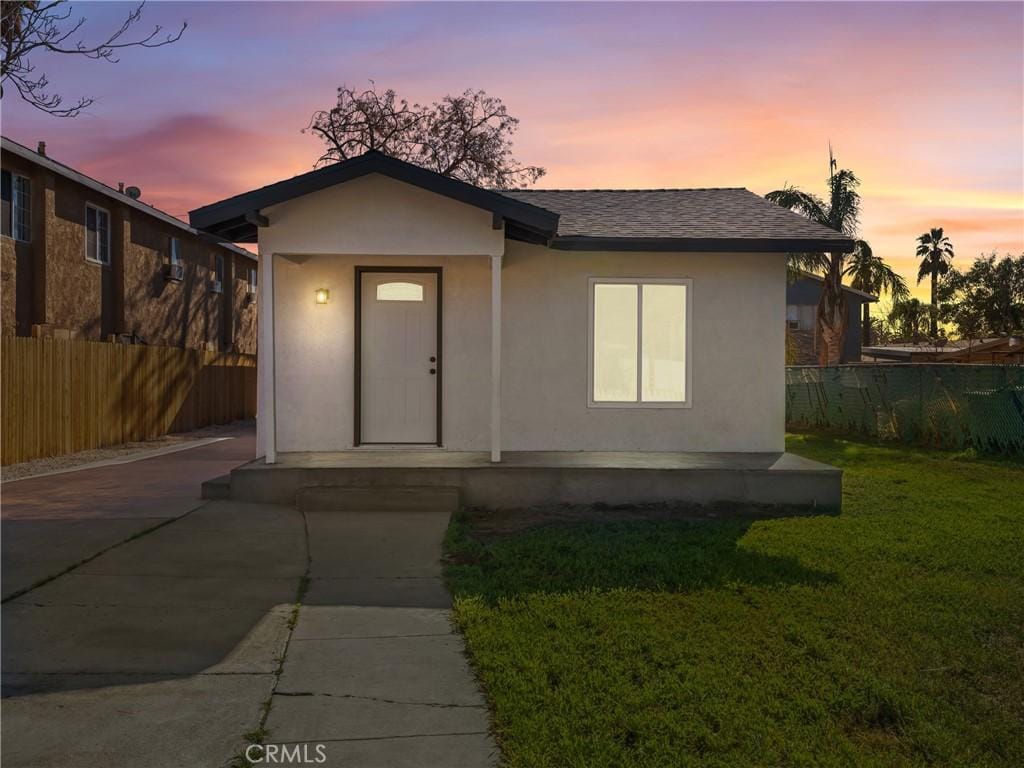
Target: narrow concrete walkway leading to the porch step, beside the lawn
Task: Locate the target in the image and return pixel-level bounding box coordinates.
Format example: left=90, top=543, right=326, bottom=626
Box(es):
left=266, top=512, right=498, bottom=768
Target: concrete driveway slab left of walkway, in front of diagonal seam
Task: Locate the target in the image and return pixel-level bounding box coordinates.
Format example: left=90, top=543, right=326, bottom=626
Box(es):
left=2, top=502, right=306, bottom=768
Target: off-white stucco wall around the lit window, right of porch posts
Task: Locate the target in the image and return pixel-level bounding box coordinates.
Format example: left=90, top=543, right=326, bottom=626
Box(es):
left=502, top=242, right=785, bottom=452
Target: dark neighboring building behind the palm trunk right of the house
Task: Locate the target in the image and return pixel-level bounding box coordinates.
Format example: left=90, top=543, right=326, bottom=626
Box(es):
left=785, top=272, right=879, bottom=366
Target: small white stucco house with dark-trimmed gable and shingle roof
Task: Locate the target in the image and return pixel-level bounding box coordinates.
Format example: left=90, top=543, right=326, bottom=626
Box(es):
left=190, top=153, right=853, bottom=512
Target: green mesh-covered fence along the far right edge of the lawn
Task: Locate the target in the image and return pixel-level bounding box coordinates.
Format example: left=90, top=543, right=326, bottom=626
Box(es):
left=785, top=364, right=1024, bottom=453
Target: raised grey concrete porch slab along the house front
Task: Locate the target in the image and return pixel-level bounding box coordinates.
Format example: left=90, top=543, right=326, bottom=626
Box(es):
left=211, top=449, right=843, bottom=509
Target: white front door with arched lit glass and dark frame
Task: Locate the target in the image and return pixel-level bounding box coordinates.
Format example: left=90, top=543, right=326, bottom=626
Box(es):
left=358, top=269, right=440, bottom=444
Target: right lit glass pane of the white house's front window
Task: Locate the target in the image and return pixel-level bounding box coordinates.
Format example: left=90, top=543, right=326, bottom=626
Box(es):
left=640, top=284, right=686, bottom=402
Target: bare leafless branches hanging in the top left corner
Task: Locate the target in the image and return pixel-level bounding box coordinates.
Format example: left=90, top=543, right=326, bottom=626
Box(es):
left=0, top=0, right=188, bottom=118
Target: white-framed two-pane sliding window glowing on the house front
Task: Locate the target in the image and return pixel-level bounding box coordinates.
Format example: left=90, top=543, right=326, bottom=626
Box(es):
left=587, top=278, right=693, bottom=408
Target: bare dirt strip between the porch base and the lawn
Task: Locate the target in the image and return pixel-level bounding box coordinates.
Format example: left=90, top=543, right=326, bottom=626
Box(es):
left=464, top=502, right=825, bottom=540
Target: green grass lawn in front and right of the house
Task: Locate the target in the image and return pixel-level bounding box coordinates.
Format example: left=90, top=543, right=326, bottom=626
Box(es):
left=446, top=435, right=1024, bottom=768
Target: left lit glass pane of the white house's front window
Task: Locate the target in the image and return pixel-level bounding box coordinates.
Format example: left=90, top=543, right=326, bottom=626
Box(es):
left=593, top=283, right=637, bottom=402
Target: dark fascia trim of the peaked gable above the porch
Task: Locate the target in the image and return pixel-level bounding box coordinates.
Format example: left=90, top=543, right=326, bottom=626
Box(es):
left=188, top=152, right=558, bottom=243
